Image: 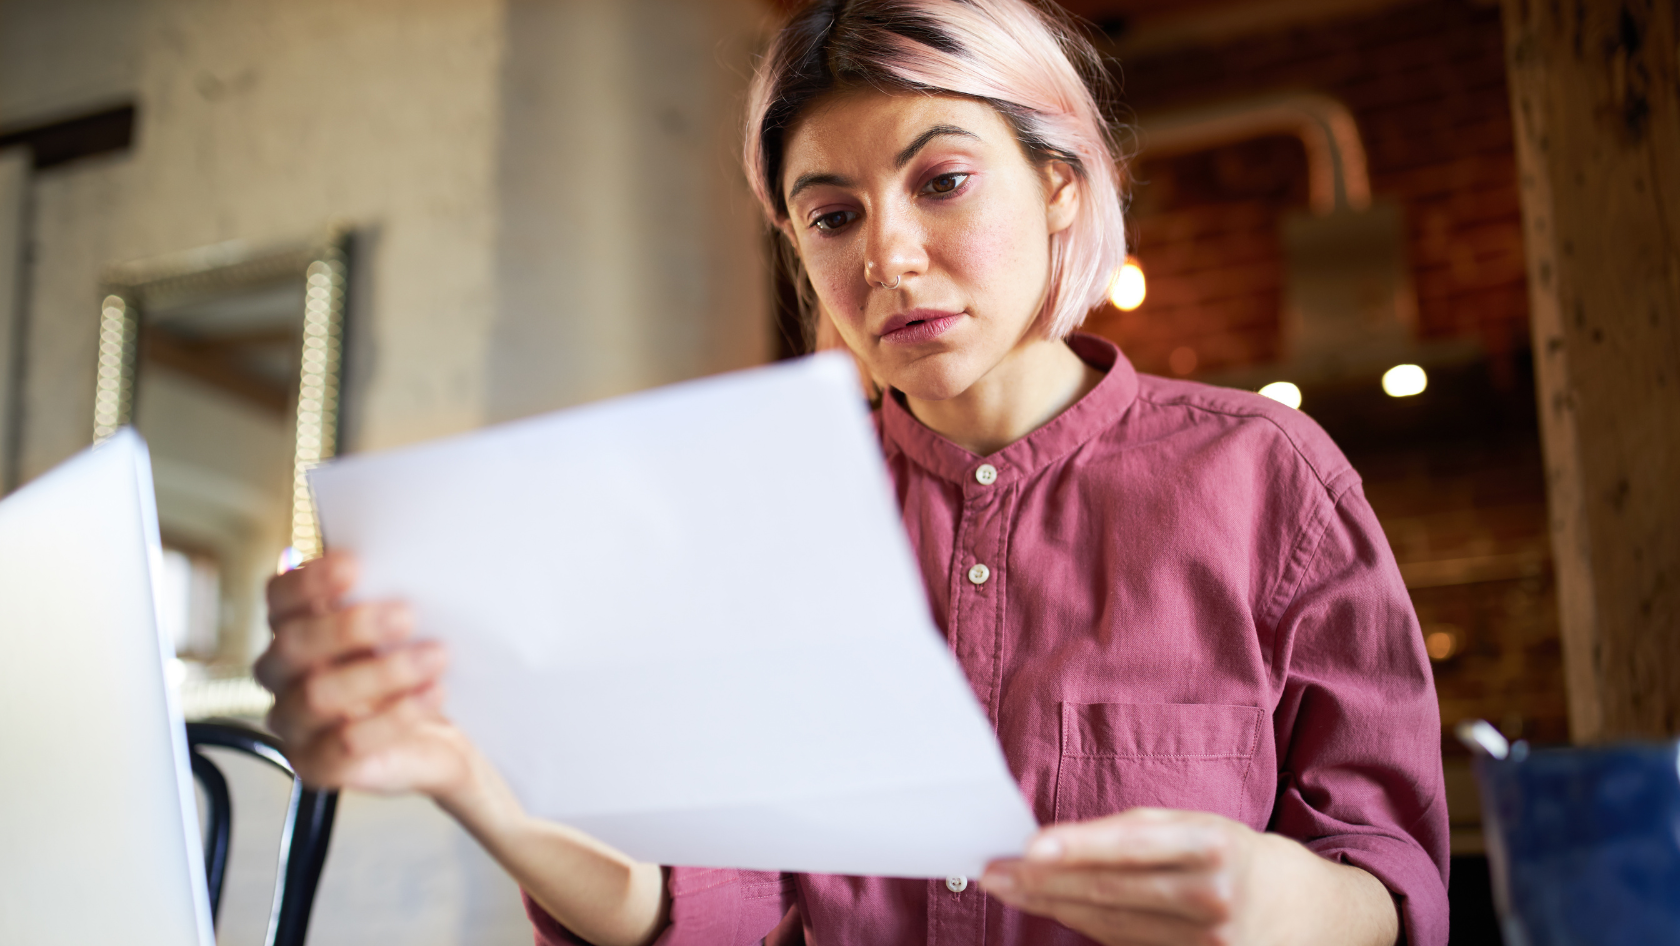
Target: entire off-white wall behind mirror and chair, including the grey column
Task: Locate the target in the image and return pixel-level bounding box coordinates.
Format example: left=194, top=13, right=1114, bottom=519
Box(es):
left=0, top=0, right=771, bottom=946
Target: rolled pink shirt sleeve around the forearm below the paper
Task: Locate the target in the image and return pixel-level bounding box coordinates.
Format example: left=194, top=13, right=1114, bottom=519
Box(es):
left=524, top=867, right=800, bottom=946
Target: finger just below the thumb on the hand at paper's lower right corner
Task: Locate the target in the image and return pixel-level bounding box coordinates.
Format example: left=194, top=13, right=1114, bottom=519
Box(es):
left=979, top=862, right=1233, bottom=924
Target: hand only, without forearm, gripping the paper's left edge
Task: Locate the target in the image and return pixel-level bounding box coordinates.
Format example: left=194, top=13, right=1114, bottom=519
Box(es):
left=255, top=553, right=474, bottom=798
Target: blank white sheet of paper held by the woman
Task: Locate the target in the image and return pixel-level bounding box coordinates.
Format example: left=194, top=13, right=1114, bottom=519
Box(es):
left=311, top=355, right=1037, bottom=877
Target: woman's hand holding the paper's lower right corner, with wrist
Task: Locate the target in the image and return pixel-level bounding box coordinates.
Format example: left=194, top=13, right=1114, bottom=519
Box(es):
left=981, top=808, right=1399, bottom=946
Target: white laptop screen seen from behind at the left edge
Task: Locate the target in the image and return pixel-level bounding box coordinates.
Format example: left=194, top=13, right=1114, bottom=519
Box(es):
left=0, top=430, right=213, bottom=946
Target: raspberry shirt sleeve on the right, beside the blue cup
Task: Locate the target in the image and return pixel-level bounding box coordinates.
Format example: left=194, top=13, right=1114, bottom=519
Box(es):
left=1270, top=482, right=1448, bottom=946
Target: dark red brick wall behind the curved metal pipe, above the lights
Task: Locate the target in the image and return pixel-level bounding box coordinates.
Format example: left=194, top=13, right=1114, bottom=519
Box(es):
left=1089, top=0, right=1527, bottom=373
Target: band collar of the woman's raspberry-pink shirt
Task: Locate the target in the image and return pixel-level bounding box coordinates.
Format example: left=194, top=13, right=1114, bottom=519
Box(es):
left=880, top=333, right=1137, bottom=486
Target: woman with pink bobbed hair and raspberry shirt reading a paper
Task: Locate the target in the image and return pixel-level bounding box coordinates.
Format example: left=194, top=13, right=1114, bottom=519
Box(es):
left=257, top=0, right=1446, bottom=946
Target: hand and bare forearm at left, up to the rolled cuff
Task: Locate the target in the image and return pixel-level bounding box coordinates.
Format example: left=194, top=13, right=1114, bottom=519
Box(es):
left=255, top=553, right=669, bottom=946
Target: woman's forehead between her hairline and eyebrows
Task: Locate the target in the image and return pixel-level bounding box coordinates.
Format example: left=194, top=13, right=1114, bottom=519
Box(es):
left=781, top=89, right=1015, bottom=179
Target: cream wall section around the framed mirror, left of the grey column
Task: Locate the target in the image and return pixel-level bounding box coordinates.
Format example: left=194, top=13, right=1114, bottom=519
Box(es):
left=24, top=0, right=504, bottom=477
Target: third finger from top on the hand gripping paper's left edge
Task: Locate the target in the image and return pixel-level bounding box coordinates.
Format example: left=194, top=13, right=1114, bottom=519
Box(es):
left=269, top=642, right=447, bottom=744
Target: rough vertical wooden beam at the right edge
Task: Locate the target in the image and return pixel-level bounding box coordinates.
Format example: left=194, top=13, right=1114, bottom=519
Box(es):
left=1504, top=0, right=1680, bottom=743
